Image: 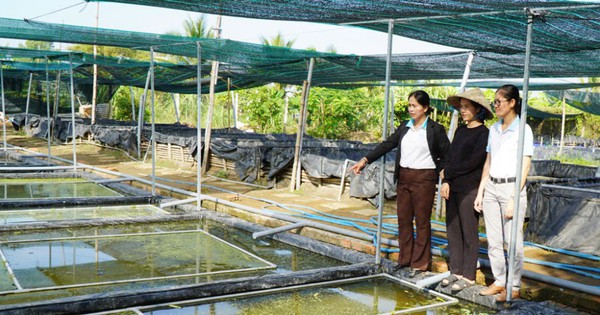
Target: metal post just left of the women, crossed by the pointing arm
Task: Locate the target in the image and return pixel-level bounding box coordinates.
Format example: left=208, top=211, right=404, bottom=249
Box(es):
left=375, top=19, right=399, bottom=265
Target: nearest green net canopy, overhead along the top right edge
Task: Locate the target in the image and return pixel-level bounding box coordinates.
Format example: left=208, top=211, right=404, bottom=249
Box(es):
left=89, top=0, right=600, bottom=53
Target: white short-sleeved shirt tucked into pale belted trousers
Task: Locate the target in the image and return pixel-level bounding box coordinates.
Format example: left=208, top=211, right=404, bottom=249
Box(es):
left=486, top=117, right=533, bottom=178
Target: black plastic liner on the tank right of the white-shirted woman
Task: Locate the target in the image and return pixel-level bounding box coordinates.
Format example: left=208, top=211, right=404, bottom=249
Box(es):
left=525, top=178, right=600, bottom=255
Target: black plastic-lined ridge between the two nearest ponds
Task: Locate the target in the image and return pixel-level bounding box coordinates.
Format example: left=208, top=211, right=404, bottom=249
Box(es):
left=0, top=264, right=377, bottom=315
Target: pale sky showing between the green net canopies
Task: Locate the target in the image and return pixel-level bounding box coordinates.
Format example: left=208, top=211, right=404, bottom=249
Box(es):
left=0, top=0, right=464, bottom=55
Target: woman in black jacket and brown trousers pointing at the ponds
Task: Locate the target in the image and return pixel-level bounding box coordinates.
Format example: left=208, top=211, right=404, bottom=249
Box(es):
left=350, top=90, right=450, bottom=277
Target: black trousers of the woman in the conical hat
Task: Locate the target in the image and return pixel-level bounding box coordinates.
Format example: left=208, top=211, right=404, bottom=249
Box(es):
left=446, top=193, right=479, bottom=280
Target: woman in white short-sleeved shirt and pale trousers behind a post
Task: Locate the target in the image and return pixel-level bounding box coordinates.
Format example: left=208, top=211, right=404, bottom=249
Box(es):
left=474, top=84, right=533, bottom=302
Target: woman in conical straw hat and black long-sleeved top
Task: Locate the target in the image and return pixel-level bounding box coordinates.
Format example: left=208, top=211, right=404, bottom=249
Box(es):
left=440, top=88, right=494, bottom=293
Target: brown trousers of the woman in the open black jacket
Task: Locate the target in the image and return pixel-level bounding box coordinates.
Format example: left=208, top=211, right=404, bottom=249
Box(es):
left=396, top=168, right=438, bottom=270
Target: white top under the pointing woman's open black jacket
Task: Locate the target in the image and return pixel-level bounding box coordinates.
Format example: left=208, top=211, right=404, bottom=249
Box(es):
left=400, top=117, right=435, bottom=169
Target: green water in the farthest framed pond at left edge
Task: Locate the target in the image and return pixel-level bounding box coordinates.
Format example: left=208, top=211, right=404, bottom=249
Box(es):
left=0, top=179, right=122, bottom=200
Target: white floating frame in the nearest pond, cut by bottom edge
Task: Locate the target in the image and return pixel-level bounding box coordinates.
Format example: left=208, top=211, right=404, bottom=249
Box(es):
left=98, top=274, right=458, bottom=315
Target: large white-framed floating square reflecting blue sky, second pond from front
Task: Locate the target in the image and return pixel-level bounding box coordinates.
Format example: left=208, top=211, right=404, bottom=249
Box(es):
left=0, top=230, right=277, bottom=295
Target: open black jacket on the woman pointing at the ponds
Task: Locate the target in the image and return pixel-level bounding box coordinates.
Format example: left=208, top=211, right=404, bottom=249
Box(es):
left=365, top=119, right=450, bottom=183
